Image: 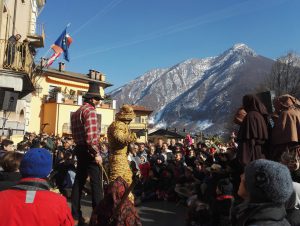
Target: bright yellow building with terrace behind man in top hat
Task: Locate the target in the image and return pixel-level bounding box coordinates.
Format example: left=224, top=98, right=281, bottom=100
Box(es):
left=28, top=63, right=115, bottom=136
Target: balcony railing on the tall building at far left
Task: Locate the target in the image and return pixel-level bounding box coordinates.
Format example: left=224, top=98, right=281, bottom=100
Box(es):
left=0, top=39, right=34, bottom=74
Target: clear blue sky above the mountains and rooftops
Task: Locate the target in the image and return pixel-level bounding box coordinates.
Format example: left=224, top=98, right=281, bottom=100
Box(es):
left=39, top=0, right=300, bottom=89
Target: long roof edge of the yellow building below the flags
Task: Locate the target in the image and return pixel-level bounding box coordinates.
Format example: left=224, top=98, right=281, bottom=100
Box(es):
left=43, top=68, right=112, bottom=88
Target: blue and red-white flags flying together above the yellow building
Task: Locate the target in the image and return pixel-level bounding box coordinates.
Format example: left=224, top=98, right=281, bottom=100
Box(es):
left=46, top=26, right=73, bottom=67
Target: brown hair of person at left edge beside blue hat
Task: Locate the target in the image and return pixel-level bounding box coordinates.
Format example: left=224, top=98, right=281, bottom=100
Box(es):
left=1, top=152, right=23, bottom=172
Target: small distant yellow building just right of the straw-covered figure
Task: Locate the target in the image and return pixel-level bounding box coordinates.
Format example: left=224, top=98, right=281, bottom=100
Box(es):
left=129, top=105, right=153, bottom=143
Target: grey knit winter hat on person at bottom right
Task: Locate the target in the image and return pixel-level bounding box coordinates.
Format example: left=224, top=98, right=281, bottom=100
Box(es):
left=245, top=159, right=293, bottom=204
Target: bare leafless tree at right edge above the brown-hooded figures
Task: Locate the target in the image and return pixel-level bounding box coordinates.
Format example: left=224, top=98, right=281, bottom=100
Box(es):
left=264, top=52, right=300, bottom=98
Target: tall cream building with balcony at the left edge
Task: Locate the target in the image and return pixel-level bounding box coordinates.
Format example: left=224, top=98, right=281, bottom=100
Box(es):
left=0, top=0, right=46, bottom=137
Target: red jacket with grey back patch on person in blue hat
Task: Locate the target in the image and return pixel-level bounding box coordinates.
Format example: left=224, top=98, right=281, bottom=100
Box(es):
left=0, top=178, right=74, bottom=226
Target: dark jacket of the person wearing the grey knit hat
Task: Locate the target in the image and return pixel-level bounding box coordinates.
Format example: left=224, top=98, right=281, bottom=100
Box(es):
left=235, top=203, right=290, bottom=226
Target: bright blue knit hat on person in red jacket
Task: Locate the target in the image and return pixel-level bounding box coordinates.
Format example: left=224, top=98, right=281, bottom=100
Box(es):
left=20, top=148, right=52, bottom=178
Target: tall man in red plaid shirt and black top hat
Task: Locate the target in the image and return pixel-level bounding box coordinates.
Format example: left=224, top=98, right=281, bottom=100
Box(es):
left=71, top=82, right=103, bottom=225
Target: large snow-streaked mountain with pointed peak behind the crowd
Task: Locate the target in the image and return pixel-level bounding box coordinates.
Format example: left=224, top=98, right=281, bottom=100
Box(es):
left=110, top=44, right=273, bottom=132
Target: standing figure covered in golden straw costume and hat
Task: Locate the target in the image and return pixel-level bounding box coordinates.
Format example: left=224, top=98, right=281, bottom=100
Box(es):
left=107, top=105, right=136, bottom=188
